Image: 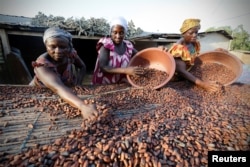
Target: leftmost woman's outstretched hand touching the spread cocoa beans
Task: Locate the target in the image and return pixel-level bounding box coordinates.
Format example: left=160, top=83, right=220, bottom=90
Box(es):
left=79, top=104, right=98, bottom=120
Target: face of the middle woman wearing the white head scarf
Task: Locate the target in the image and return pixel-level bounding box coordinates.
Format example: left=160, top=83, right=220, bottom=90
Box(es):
left=111, top=25, right=126, bottom=44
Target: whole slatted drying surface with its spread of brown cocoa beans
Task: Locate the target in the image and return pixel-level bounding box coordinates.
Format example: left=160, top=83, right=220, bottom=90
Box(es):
left=0, top=81, right=250, bottom=166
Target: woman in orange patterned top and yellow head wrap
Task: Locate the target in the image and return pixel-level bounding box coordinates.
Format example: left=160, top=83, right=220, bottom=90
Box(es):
left=169, top=19, right=219, bottom=91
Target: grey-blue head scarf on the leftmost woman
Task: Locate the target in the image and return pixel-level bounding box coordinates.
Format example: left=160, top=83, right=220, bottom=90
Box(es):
left=43, top=27, right=73, bottom=48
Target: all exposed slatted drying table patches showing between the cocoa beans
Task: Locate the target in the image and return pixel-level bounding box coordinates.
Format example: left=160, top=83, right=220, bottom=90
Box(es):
left=0, top=85, right=158, bottom=154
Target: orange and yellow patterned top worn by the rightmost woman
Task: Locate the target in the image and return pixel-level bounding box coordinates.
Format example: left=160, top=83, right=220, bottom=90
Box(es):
left=169, top=41, right=200, bottom=67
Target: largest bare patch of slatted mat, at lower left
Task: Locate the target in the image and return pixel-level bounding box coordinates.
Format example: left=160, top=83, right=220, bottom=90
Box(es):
left=0, top=107, right=82, bottom=154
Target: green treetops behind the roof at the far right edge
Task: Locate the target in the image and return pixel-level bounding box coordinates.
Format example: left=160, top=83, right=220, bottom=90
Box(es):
left=206, top=25, right=250, bottom=51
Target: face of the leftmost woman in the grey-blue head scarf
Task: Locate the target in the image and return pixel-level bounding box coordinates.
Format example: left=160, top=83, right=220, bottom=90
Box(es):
left=45, top=37, right=70, bottom=62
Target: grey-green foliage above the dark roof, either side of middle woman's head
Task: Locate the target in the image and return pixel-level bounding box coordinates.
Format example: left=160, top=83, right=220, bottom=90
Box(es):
left=31, top=12, right=143, bottom=38
